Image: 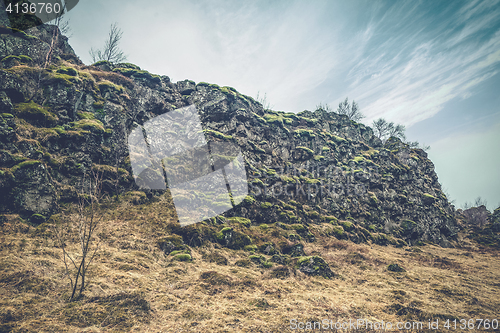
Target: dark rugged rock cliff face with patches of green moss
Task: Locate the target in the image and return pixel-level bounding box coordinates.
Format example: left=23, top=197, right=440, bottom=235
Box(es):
left=0, top=25, right=459, bottom=247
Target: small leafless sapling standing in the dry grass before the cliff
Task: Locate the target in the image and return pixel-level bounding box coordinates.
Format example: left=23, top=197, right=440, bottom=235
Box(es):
left=53, top=171, right=103, bottom=302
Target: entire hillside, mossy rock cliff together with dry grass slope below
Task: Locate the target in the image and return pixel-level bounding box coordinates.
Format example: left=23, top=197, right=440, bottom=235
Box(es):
left=0, top=26, right=500, bottom=332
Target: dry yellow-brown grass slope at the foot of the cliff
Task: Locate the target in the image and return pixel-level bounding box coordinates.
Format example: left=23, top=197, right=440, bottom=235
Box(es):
left=0, top=199, right=500, bottom=332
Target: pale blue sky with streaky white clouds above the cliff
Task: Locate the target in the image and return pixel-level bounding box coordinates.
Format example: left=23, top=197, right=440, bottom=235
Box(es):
left=59, top=0, right=500, bottom=210
